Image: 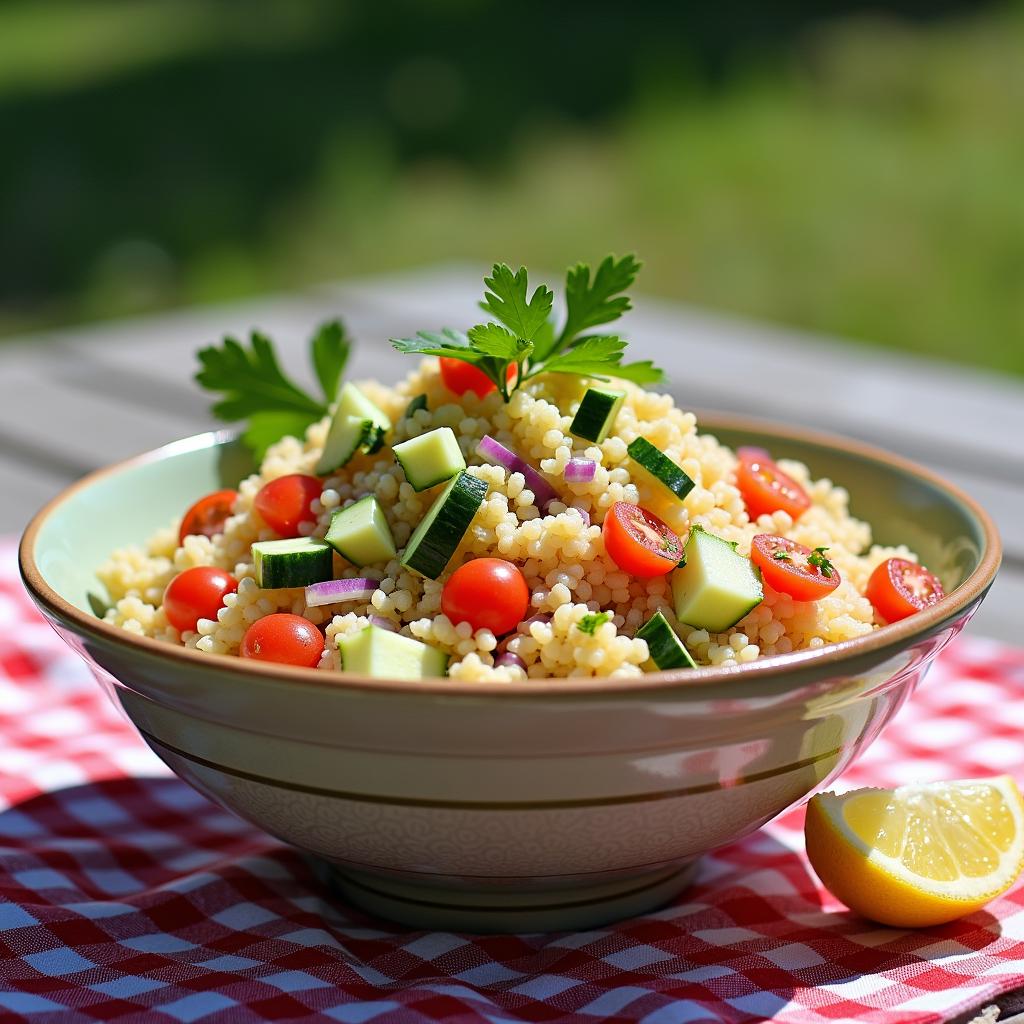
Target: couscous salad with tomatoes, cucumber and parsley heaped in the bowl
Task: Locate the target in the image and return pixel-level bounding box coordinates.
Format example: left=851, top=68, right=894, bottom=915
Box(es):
left=99, top=257, right=942, bottom=682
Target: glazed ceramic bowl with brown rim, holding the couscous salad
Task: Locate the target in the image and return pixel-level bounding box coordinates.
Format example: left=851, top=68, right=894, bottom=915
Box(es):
left=20, top=416, right=999, bottom=931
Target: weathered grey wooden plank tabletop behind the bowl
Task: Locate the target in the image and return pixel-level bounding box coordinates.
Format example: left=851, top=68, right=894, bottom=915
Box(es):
left=0, top=266, right=1024, bottom=642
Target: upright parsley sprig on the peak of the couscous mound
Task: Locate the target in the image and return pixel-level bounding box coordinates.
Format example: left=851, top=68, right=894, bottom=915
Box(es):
left=391, top=255, right=665, bottom=401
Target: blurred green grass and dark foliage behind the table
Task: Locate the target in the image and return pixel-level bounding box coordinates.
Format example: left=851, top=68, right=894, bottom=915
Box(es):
left=0, top=0, right=1024, bottom=374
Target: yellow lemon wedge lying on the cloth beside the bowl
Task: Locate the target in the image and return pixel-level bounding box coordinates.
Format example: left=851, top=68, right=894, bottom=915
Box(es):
left=804, top=775, right=1024, bottom=928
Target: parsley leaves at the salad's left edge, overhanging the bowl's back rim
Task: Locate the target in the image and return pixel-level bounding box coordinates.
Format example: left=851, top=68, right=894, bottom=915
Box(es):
left=196, top=319, right=352, bottom=460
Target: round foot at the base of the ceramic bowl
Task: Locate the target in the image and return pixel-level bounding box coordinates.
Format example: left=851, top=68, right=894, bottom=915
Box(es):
left=324, top=860, right=697, bottom=933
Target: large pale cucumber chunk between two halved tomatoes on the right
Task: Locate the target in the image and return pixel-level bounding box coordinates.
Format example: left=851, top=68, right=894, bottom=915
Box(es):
left=672, top=525, right=764, bottom=633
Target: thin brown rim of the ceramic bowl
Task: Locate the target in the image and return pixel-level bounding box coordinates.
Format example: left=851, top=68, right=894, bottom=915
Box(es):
left=18, top=410, right=1001, bottom=699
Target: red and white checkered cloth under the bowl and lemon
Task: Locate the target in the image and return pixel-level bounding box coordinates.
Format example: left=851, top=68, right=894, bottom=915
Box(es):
left=6, top=544, right=1024, bottom=1024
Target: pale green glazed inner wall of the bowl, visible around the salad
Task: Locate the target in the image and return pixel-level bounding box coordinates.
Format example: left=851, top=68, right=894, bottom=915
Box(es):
left=33, top=415, right=984, bottom=612
